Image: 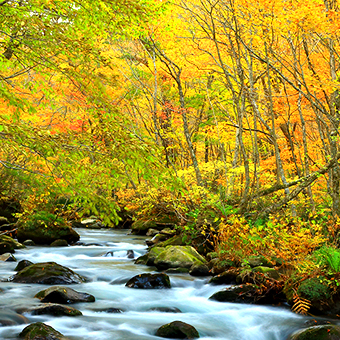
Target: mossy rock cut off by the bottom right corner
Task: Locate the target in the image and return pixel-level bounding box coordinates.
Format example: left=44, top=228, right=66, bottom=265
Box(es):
left=288, top=325, right=340, bottom=340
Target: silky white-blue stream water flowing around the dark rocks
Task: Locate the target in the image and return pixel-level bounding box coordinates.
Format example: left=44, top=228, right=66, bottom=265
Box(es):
left=0, top=229, right=326, bottom=340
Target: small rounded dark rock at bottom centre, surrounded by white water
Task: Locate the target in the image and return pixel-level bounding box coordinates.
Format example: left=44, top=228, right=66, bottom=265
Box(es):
left=156, top=321, right=199, bottom=339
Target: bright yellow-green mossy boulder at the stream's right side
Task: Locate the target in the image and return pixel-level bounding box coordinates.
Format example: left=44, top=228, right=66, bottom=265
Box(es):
left=154, top=246, right=206, bottom=270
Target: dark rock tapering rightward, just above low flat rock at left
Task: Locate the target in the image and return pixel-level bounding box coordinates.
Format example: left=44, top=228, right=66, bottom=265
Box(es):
left=34, top=286, right=95, bottom=304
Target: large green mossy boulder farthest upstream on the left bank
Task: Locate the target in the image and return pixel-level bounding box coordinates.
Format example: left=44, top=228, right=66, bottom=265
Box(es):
left=17, top=212, right=80, bottom=244
